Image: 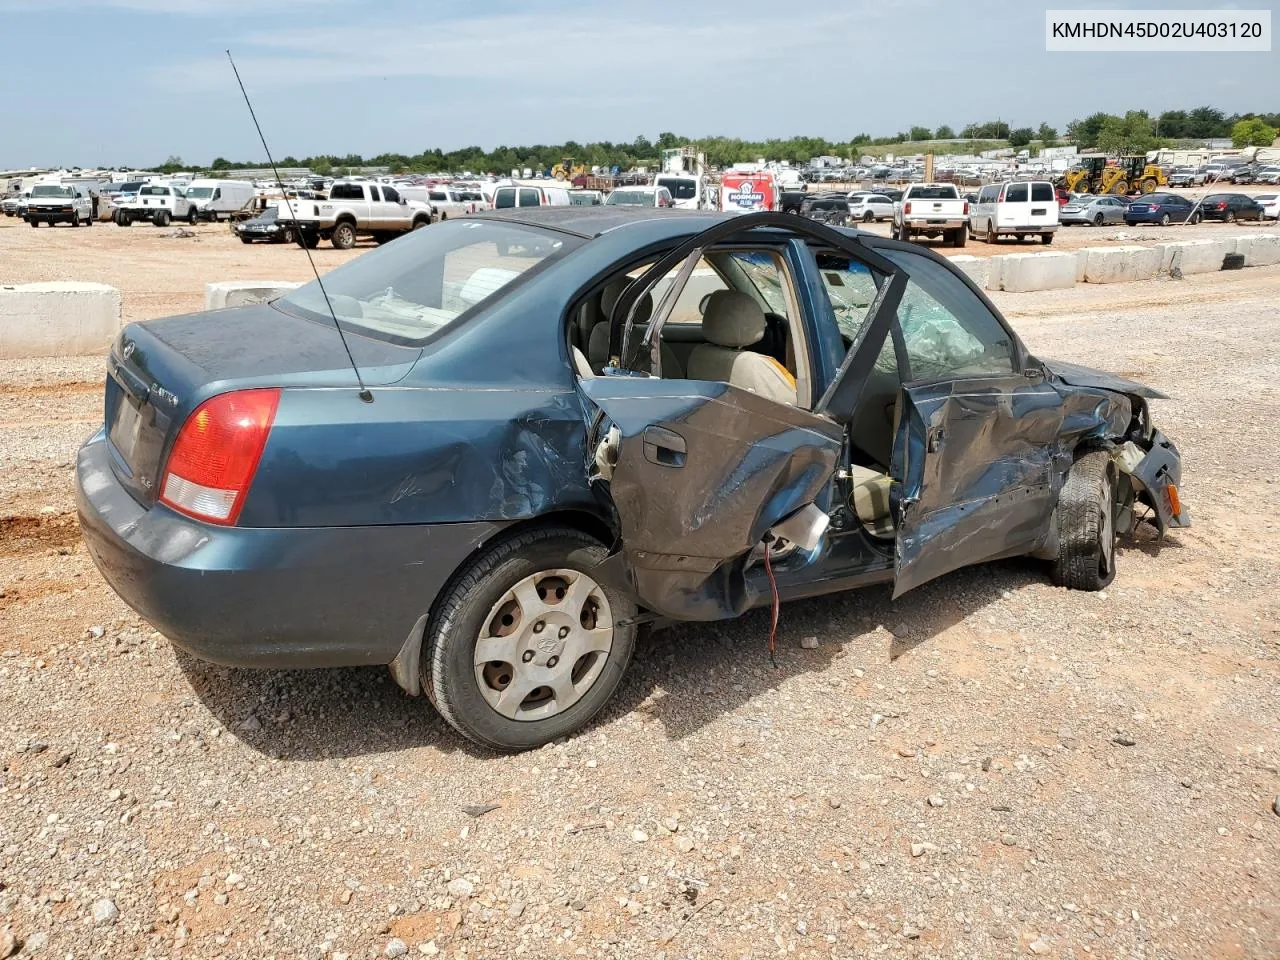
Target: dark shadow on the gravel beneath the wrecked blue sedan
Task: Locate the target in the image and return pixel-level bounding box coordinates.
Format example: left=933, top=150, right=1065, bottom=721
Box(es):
left=175, top=559, right=1047, bottom=760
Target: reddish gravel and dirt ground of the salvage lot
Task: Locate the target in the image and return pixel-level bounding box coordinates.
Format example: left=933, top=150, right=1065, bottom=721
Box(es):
left=0, top=227, right=1280, bottom=960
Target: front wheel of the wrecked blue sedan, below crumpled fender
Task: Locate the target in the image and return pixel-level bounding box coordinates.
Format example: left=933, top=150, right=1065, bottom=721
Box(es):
left=1053, top=451, right=1116, bottom=590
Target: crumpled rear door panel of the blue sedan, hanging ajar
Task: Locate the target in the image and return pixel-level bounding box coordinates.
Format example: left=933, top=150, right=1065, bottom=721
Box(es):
left=580, top=376, right=842, bottom=620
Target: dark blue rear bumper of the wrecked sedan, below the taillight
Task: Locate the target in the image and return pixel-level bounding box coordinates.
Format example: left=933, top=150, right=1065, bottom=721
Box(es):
left=76, top=430, right=504, bottom=668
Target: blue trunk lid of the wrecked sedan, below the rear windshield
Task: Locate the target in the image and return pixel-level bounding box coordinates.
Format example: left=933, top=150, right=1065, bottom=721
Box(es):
left=102, top=303, right=422, bottom=506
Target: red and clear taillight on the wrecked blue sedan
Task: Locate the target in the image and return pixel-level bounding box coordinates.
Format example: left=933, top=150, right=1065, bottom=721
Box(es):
left=160, top=388, right=280, bottom=526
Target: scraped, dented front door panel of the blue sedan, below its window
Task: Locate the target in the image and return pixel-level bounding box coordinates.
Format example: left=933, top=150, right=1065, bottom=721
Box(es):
left=892, top=374, right=1062, bottom=596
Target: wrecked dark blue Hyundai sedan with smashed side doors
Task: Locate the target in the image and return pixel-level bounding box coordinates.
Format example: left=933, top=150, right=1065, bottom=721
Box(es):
left=76, top=206, right=1189, bottom=750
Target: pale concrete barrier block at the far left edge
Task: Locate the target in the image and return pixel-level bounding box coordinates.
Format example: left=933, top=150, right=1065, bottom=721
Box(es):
left=0, top=283, right=124, bottom=360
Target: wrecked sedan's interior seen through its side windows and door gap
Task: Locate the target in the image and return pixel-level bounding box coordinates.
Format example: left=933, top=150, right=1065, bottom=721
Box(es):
left=568, top=235, right=1014, bottom=540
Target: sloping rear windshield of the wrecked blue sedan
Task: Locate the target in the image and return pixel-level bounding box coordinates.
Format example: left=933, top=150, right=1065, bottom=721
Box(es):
left=279, top=220, right=580, bottom=343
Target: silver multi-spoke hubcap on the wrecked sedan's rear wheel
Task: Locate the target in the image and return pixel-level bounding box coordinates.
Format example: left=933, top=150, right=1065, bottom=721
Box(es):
left=475, top=570, right=613, bottom=721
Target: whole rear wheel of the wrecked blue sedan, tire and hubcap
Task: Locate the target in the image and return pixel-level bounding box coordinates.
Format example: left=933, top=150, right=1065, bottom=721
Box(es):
left=422, top=527, right=636, bottom=750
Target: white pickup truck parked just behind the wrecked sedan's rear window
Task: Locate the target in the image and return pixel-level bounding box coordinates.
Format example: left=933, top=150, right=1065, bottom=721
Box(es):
left=278, top=180, right=431, bottom=250
